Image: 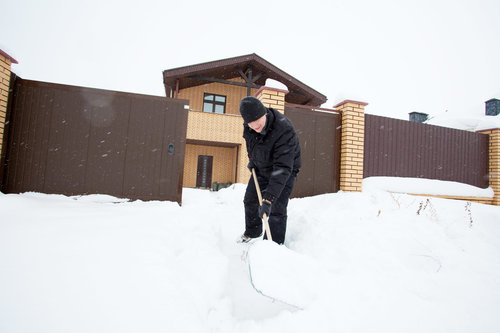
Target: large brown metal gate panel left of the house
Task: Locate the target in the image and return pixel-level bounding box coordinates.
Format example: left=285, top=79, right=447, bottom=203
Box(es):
left=2, top=78, right=188, bottom=203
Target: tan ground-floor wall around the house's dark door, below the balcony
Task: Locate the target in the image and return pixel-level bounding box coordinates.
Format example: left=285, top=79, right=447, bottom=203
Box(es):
left=183, top=144, right=238, bottom=187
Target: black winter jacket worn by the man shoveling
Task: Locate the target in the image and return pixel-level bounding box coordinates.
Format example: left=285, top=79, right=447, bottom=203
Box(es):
left=243, top=108, right=301, bottom=201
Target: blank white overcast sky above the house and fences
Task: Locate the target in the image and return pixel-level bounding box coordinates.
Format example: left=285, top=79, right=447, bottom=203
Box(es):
left=0, top=0, right=500, bottom=119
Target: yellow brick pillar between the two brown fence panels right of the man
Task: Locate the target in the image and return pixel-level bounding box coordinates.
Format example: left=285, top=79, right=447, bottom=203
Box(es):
left=334, top=100, right=368, bottom=192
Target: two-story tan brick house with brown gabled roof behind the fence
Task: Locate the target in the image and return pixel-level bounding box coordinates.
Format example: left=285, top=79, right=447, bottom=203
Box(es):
left=163, top=54, right=326, bottom=188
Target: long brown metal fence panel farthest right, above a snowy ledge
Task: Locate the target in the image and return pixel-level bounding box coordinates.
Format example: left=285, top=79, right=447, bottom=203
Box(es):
left=363, top=115, right=488, bottom=188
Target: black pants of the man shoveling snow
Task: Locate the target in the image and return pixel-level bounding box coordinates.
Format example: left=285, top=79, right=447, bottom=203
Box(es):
left=243, top=175, right=295, bottom=244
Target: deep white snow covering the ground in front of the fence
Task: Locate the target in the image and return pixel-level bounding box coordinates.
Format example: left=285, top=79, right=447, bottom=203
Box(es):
left=0, top=184, right=500, bottom=333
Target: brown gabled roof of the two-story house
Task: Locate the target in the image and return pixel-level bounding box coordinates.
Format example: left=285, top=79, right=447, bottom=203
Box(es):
left=163, top=53, right=326, bottom=106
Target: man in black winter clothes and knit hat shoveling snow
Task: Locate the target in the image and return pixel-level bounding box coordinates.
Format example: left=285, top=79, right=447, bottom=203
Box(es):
left=235, top=96, right=301, bottom=244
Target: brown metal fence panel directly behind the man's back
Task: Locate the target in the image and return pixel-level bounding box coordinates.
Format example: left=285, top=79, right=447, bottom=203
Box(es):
left=285, top=106, right=342, bottom=197
